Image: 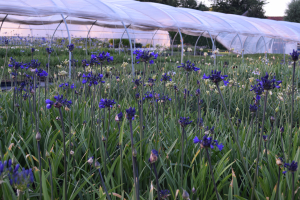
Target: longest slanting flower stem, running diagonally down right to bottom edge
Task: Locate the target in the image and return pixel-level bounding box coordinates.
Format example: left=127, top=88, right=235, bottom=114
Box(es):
left=216, top=84, right=259, bottom=199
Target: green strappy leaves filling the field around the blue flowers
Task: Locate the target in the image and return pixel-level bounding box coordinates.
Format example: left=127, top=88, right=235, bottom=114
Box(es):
left=0, top=45, right=300, bottom=200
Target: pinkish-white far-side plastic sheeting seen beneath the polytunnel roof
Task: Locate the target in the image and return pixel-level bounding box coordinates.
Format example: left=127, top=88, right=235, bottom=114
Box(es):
left=0, top=21, right=170, bottom=47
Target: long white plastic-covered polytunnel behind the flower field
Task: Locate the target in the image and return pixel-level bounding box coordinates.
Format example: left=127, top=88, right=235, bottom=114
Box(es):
left=0, top=0, right=300, bottom=54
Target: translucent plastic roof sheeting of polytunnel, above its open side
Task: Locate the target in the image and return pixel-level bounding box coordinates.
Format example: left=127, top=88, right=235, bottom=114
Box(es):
left=0, top=0, right=300, bottom=53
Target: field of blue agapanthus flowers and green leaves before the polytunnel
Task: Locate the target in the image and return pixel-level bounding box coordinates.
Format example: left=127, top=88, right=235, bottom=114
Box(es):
left=0, top=41, right=300, bottom=200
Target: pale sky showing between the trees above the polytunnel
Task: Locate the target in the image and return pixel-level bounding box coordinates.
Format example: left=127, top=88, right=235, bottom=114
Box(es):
left=198, top=0, right=292, bottom=17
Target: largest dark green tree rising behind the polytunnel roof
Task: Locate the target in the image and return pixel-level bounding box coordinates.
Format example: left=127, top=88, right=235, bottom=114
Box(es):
left=211, top=0, right=266, bottom=18
